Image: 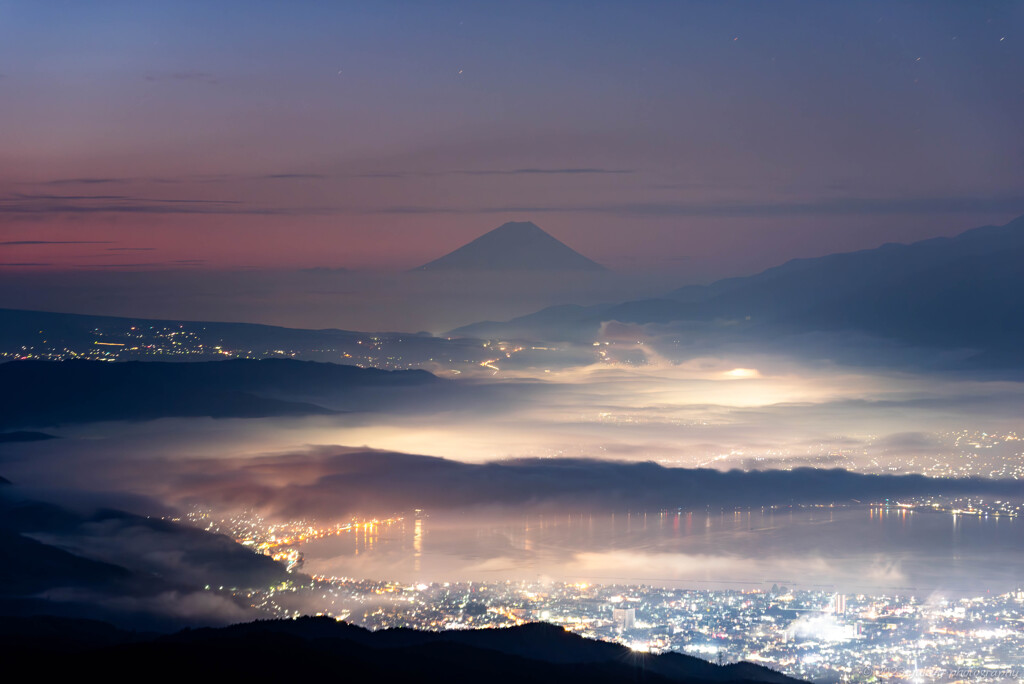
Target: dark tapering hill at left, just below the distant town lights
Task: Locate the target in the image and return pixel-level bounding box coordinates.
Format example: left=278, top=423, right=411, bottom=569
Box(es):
left=0, top=359, right=441, bottom=429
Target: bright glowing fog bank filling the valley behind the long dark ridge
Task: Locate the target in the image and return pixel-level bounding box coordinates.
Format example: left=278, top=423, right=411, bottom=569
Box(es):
left=0, top=354, right=1024, bottom=498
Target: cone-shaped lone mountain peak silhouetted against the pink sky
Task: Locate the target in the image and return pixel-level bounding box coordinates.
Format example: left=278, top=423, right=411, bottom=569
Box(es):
left=414, top=221, right=607, bottom=271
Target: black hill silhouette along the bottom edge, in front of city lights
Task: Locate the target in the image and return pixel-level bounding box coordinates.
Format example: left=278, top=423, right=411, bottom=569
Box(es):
left=0, top=617, right=799, bottom=684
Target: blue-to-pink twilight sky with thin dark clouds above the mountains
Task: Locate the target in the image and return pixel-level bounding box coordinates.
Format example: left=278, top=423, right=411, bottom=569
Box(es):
left=0, top=0, right=1024, bottom=276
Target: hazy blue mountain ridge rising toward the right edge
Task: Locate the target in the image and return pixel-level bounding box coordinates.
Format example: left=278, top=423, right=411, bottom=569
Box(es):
left=453, top=217, right=1024, bottom=364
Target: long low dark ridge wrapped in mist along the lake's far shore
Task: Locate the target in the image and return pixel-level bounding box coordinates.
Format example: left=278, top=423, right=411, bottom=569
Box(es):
left=37, top=447, right=1024, bottom=521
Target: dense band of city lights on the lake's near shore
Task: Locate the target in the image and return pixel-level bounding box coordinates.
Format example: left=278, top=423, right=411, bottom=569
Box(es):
left=230, top=576, right=1024, bottom=682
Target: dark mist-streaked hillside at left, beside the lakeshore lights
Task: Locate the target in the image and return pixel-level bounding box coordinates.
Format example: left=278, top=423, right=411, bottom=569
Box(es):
left=0, top=484, right=294, bottom=630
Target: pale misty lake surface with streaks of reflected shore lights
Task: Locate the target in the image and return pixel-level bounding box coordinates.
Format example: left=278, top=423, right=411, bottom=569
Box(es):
left=303, top=507, right=1024, bottom=595
